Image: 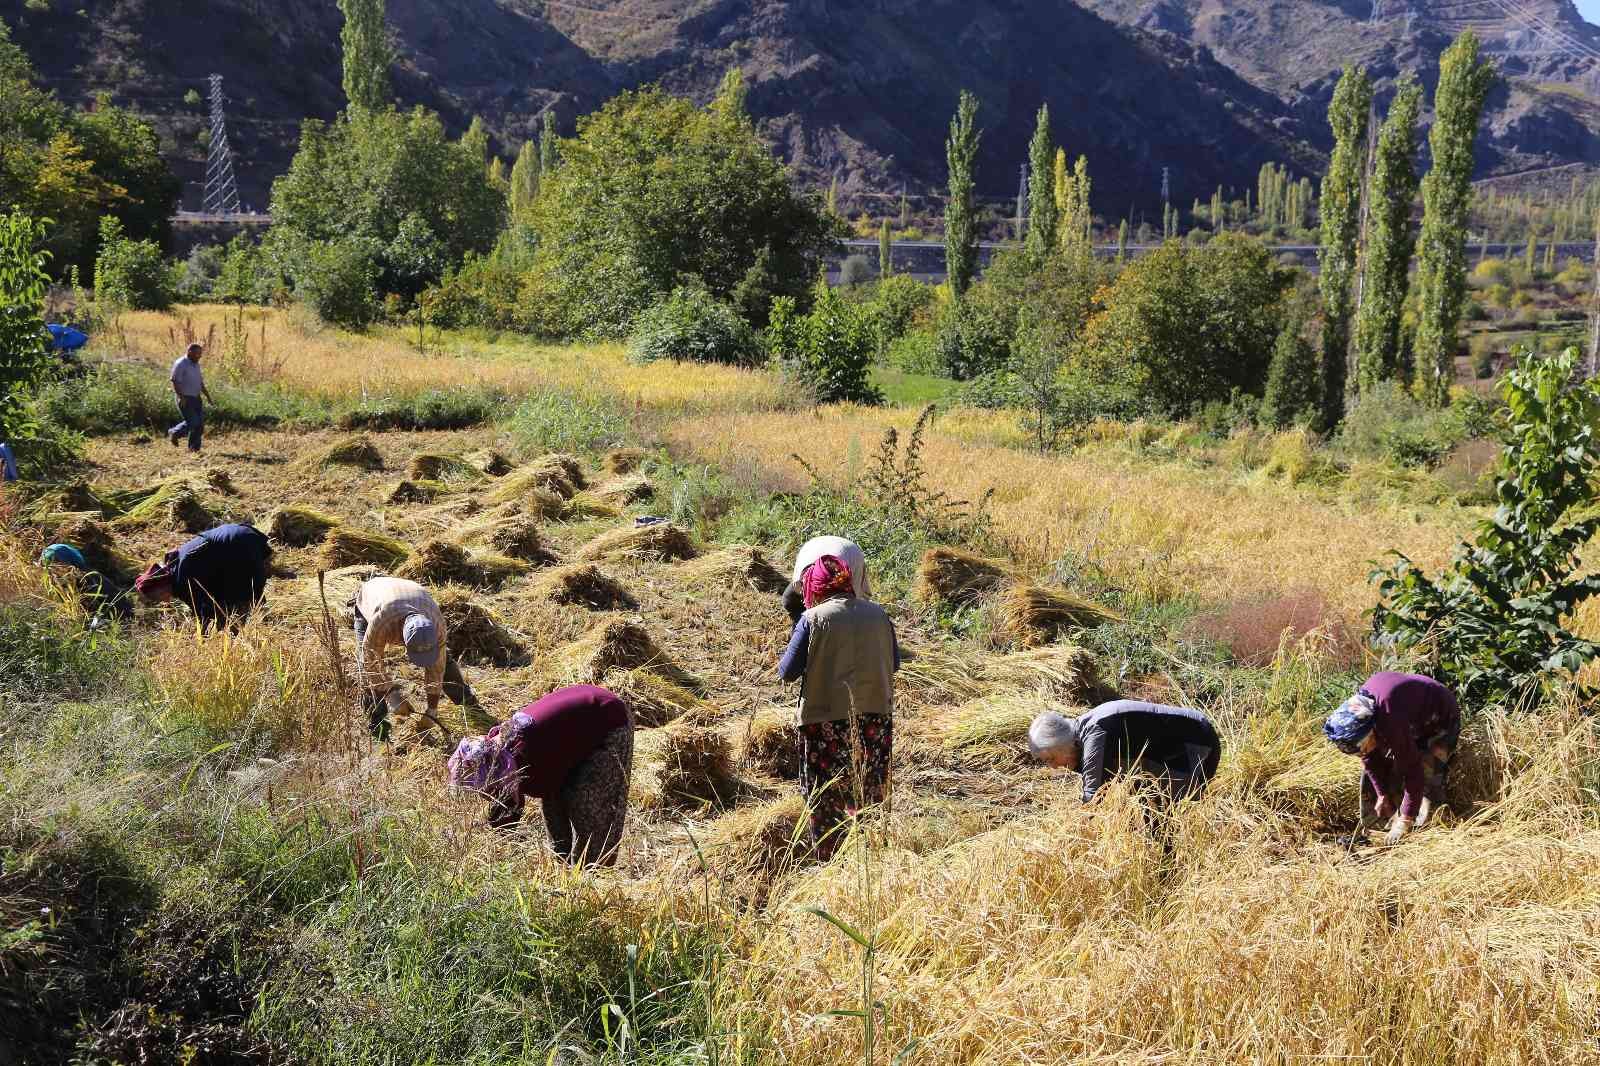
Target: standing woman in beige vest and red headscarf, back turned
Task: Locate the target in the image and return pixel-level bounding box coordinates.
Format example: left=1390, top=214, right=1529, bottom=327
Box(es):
left=778, top=555, right=899, bottom=860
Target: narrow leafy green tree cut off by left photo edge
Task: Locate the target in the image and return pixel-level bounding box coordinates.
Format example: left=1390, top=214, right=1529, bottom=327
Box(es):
left=0, top=213, right=50, bottom=440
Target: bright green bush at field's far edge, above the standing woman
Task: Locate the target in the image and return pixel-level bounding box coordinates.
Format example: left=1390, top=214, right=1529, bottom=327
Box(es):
left=766, top=277, right=883, bottom=403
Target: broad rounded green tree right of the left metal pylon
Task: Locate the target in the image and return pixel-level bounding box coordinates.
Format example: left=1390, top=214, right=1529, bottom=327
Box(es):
left=272, top=109, right=506, bottom=298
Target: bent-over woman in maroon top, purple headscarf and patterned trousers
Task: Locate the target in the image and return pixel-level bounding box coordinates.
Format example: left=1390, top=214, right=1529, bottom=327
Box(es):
left=450, top=685, right=634, bottom=866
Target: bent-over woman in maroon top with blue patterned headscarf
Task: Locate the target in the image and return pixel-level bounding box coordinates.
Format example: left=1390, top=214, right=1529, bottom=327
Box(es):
left=1322, top=672, right=1461, bottom=844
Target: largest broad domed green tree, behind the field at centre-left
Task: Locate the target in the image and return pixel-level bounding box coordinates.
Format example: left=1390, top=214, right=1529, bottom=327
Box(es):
left=525, top=90, right=838, bottom=336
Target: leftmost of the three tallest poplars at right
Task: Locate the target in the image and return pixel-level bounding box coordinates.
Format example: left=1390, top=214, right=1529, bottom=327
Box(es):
left=1317, top=66, right=1373, bottom=429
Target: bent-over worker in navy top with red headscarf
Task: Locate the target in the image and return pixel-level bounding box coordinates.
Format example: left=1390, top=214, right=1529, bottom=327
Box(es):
left=133, top=522, right=272, bottom=626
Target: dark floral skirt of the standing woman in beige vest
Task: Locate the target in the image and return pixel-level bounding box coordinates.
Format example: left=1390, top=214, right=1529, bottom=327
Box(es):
left=800, top=714, right=894, bottom=860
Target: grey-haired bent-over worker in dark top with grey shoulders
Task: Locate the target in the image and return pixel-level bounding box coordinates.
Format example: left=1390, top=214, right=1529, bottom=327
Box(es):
left=1027, top=699, right=1222, bottom=804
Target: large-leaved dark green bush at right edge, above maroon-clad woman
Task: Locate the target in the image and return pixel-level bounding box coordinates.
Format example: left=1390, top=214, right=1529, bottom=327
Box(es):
left=1373, top=349, right=1600, bottom=709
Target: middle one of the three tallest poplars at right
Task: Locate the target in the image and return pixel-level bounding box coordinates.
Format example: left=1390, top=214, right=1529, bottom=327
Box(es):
left=1349, top=77, right=1422, bottom=392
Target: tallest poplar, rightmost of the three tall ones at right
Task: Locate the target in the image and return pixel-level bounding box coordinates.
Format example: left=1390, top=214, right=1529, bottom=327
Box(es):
left=1416, top=30, right=1494, bottom=407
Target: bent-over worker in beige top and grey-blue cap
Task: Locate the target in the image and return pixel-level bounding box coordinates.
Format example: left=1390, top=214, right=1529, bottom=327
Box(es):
left=360, top=578, right=478, bottom=736
